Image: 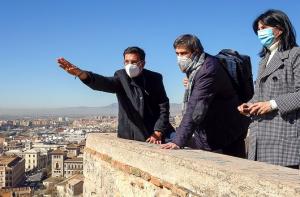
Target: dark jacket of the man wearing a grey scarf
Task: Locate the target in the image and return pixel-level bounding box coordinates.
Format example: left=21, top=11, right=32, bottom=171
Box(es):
left=173, top=54, right=248, bottom=150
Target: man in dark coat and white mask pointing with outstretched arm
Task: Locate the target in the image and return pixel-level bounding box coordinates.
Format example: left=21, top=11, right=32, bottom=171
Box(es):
left=58, top=47, right=172, bottom=144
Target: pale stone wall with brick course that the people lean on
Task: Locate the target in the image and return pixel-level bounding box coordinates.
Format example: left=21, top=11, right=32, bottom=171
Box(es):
left=84, top=134, right=300, bottom=197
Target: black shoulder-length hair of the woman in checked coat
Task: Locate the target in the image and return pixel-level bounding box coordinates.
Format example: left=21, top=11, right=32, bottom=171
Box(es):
left=252, top=9, right=298, bottom=57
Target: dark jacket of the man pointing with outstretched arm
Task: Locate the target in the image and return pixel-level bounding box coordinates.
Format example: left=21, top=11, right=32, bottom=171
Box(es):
left=83, top=69, right=171, bottom=141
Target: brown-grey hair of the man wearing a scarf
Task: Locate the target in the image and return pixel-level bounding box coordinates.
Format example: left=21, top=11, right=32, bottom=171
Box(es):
left=173, top=34, right=204, bottom=54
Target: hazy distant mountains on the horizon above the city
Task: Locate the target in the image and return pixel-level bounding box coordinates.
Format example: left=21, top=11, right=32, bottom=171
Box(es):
left=0, top=103, right=181, bottom=119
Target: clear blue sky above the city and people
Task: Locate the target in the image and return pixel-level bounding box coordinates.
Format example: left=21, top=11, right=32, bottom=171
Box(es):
left=0, top=0, right=300, bottom=108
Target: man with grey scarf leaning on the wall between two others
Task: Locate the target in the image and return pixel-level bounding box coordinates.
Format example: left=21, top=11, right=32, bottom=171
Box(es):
left=162, top=34, right=248, bottom=157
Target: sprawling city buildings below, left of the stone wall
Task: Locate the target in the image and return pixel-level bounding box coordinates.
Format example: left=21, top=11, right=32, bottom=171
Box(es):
left=0, top=115, right=181, bottom=197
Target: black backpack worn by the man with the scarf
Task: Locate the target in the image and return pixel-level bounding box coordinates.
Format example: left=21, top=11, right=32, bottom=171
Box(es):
left=216, top=49, right=254, bottom=103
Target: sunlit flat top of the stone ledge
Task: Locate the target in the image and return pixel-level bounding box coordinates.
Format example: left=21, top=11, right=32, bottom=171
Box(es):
left=86, top=133, right=300, bottom=196
